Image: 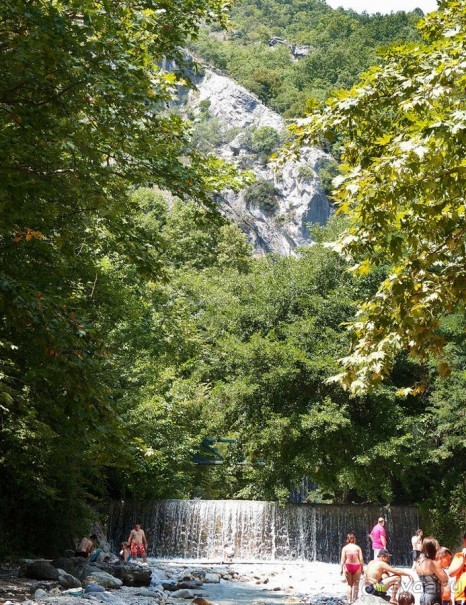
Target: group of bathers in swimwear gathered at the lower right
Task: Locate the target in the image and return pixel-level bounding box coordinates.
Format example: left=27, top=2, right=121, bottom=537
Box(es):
left=340, top=517, right=466, bottom=605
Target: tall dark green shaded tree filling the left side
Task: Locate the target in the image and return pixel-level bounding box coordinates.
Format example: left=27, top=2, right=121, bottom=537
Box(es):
left=0, top=0, right=237, bottom=551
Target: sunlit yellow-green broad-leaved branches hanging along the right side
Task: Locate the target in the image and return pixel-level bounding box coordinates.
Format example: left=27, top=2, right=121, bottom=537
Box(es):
left=294, top=0, right=466, bottom=392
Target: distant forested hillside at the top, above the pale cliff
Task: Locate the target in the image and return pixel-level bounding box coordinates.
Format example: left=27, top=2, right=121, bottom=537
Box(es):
left=191, top=0, right=422, bottom=116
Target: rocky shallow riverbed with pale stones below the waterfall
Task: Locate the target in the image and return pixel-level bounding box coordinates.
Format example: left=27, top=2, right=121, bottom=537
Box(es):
left=0, top=558, right=350, bottom=605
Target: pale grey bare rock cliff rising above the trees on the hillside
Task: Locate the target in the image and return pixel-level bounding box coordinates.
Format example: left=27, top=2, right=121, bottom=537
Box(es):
left=187, top=68, right=332, bottom=255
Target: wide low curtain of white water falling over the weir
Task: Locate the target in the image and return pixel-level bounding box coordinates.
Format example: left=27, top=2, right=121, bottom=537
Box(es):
left=109, top=500, right=419, bottom=565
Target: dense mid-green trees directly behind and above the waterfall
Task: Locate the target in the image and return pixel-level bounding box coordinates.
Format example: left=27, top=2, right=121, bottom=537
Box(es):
left=109, top=201, right=465, bottom=544
